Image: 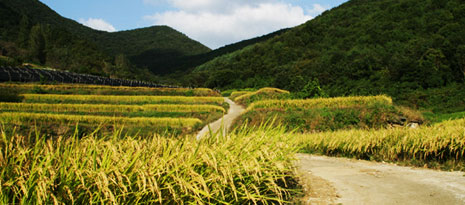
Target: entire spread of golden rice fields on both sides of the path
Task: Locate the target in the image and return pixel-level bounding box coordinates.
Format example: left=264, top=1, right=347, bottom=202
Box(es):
left=0, top=84, right=465, bottom=204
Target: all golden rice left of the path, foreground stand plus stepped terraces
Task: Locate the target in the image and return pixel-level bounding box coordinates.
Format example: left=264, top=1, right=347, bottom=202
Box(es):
left=0, top=85, right=300, bottom=204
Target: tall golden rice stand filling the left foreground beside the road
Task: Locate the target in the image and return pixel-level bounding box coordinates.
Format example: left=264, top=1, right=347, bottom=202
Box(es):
left=0, top=123, right=296, bottom=204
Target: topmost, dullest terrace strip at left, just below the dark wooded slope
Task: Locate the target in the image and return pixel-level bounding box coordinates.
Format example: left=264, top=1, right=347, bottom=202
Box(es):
left=0, top=83, right=220, bottom=97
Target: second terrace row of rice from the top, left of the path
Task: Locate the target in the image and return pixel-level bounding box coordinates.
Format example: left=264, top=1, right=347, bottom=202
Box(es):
left=22, top=94, right=224, bottom=105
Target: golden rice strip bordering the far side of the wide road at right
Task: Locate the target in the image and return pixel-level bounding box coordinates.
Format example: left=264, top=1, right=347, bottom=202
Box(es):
left=295, top=119, right=465, bottom=167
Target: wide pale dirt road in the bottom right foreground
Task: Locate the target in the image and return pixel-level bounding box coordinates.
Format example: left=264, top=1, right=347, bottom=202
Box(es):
left=298, top=154, right=465, bottom=205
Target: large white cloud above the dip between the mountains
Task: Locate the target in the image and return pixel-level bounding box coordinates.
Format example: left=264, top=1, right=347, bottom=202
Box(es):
left=144, top=0, right=312, bottom=48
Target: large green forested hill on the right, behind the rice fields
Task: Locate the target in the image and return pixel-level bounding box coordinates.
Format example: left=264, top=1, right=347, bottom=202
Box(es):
left=191, top=0, right=465, bottom=96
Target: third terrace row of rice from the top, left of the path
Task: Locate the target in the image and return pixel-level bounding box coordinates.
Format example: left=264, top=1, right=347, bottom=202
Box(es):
left=0, top=103, right=226, bottom=113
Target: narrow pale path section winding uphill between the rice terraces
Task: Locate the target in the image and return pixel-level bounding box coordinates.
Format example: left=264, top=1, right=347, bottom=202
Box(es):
left=197, top=98, right=244, bottom=139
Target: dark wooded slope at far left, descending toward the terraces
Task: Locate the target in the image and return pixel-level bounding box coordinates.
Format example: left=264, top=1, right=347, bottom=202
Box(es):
left=0, top=3, right=157, bottom=80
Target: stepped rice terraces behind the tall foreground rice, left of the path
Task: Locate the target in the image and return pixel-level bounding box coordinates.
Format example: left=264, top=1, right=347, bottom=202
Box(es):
left=0, top=84, right=226, bottom=135
